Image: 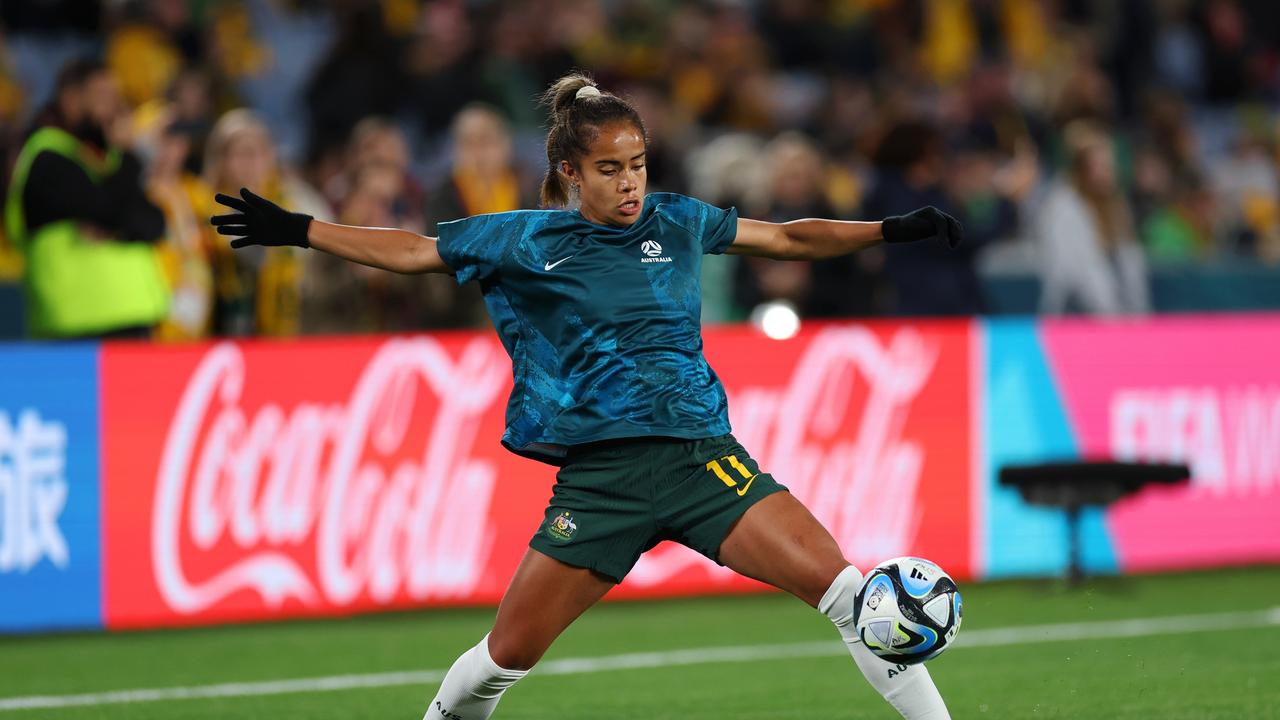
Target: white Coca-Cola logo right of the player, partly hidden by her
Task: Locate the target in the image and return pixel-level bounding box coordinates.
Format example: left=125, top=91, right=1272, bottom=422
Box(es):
left=627, top=325, right=940, bottom=587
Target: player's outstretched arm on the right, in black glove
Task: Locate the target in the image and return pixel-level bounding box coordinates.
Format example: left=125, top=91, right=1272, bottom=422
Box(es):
left=728, top=206, right=964, bottom=260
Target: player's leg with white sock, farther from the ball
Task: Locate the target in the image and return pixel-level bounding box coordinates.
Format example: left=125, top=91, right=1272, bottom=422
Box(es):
left=422, top=550, right=614, bottom=720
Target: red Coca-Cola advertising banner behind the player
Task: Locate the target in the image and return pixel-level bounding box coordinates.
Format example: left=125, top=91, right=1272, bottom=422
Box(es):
left=101, top=322, right=973, bottom=628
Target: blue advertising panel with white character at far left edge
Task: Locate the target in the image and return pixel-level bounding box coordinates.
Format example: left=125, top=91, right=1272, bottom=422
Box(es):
left=0, top=345, right=102, bottom=633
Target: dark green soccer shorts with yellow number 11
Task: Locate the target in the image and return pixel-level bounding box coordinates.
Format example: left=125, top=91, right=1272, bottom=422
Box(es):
left=529, top=436, right=787, bottom=582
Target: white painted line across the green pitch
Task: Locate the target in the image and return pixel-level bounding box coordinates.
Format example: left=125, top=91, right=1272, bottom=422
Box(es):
left=0, top=607, right=1280, bottom=712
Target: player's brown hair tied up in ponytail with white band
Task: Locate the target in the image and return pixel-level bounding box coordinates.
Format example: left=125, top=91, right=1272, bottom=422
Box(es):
left=541, top=73, right=649, bottom=208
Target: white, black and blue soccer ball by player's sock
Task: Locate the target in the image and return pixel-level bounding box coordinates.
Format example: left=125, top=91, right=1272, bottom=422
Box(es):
left=854, top=557, right=961, bottom=665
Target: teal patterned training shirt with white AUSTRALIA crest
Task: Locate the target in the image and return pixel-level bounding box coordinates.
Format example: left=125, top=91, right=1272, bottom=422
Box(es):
left=439, top=192, right=737, bottom=464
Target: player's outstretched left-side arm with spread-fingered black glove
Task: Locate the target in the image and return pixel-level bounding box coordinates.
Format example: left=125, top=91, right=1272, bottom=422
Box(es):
left=209, top=187, right=452, bottom=273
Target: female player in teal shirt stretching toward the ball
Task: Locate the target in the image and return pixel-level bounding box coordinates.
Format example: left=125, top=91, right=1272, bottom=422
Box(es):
left=212, top=74, right=960, bottom=720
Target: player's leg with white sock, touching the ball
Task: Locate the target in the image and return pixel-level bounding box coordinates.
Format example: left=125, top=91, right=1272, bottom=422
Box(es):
left=719, top=492, right=950, bottom=720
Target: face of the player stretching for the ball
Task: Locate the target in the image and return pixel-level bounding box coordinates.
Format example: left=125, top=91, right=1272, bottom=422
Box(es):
left=561, top=122, right=649, bottom=225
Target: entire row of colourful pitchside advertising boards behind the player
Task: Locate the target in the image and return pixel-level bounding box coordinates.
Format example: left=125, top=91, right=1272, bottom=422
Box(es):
left=12, top=315, right=1280, bottom=632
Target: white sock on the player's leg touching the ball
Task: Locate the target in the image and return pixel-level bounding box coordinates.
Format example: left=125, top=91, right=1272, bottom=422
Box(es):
left=818, top=565, right=951, bottom=720
